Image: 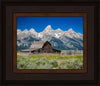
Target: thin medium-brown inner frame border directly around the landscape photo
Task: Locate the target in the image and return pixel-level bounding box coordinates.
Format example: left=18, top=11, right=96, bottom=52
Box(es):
left=13, top=13, right=87, bottom=73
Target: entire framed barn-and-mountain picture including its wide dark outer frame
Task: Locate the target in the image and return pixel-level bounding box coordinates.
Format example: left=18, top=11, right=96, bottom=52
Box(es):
left=2, top=2, right=98, bottom=85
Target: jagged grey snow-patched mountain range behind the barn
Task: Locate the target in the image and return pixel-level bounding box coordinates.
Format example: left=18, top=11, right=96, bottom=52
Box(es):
left=17, top=25, right=83, bottom=50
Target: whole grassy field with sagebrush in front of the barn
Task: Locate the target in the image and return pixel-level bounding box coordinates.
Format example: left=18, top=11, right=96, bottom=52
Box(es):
left=17, top=52, right=83, bottom=69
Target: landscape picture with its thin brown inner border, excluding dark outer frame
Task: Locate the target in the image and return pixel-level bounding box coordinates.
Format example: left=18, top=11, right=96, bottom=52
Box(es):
left=13, top=13, right=87, bottom=73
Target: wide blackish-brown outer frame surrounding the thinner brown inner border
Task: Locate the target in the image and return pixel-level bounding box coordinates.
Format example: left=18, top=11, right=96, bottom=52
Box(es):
left=0, top=0, right=100, bottom=86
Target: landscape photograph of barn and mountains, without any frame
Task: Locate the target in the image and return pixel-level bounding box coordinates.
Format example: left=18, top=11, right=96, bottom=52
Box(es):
left=16, top=16, right=84, bottom=70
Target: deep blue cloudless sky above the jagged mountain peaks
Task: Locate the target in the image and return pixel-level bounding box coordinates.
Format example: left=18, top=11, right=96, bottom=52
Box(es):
left=17, top=17, right=83, bottom=34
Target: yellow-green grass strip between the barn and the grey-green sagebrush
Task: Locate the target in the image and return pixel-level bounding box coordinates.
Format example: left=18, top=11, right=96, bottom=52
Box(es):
left=17, top=52, right=83, bottom=63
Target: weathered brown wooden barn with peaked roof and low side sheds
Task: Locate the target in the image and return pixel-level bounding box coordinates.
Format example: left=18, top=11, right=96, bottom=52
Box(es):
left=20, top=41, right=61, bottom=55
